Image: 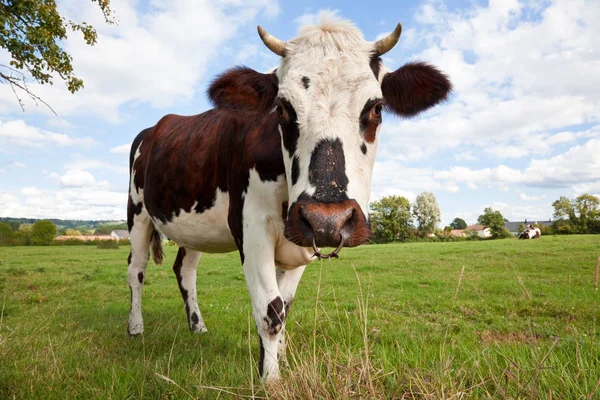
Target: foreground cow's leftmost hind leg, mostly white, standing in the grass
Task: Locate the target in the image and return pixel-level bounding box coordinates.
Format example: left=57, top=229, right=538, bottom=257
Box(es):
left=127, top=210, right=153, bottom=336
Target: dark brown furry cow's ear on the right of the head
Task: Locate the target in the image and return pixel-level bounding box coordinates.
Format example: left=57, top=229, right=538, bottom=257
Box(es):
left=381, top=62, right=452, bottom=118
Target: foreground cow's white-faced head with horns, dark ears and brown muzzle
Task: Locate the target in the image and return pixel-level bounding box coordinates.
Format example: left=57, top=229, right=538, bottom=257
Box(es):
left=210, top=20, right=451, bottom=255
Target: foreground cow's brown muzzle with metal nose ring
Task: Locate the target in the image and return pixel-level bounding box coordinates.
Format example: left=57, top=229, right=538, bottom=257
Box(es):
left=285, top=200, right=371, bottom=252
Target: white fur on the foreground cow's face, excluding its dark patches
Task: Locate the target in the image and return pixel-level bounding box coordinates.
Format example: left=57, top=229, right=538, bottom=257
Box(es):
left=277, top=20, right=382, bottom=215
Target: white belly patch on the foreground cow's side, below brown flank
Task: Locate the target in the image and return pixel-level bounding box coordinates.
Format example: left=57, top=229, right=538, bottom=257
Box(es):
left=154, top=189, right=236, bottom=253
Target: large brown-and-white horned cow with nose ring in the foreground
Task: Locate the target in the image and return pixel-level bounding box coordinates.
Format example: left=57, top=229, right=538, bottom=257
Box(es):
left=127, top=19, right=452, bottom=381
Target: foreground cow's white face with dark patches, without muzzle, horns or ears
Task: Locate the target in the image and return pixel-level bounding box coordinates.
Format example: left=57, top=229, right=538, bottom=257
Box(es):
left=276, top=23, right=383, bottom=222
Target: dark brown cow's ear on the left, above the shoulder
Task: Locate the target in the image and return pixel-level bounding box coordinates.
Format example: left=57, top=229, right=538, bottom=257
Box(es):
left=207, top=67, right=278, bottom=111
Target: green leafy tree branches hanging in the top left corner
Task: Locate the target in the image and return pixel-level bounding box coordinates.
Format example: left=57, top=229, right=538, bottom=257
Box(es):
left=0, top=0, right=114, bottom=108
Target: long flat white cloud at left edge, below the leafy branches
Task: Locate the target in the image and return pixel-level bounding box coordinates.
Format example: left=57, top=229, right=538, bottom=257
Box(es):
left=0, top=120, right=96, bottom=148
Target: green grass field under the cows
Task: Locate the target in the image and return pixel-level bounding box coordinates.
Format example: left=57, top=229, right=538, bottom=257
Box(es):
left=0, top=235, right=600, bottom=399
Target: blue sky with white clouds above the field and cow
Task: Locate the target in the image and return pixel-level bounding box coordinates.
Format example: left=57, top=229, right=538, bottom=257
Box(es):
left=0, top=0, right=600, bottom=226
